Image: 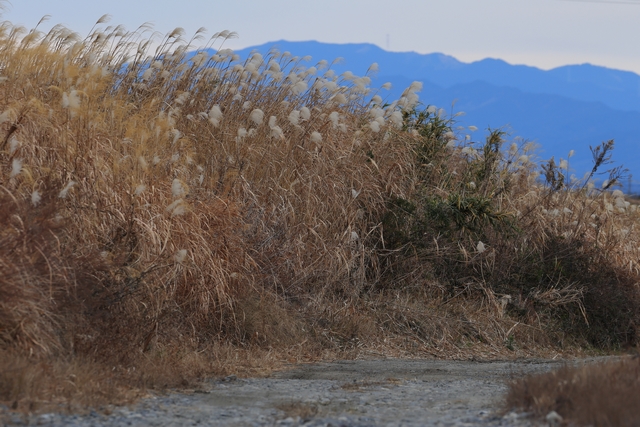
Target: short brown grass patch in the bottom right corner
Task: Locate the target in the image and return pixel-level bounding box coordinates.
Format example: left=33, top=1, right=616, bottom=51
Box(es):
left=506, top=356, right=640, bottom=426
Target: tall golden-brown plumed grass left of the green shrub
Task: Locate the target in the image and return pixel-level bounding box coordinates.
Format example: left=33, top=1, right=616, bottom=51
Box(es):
left=2, top=19, right=404, bottom=362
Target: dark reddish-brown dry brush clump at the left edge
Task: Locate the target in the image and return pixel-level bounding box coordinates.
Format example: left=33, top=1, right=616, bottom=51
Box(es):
left=0, top=188, right=73, bottom=353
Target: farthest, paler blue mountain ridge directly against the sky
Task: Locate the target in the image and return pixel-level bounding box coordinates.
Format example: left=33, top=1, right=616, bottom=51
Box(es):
left=236, top=40, right=640, bottom=112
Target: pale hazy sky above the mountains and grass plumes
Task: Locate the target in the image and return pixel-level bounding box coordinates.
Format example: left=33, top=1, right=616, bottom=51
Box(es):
left=0, top=0, right=640, bottom=74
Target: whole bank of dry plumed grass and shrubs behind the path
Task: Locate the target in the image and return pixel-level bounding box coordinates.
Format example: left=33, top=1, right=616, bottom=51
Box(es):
left=0, top=14, right=640, bottom=408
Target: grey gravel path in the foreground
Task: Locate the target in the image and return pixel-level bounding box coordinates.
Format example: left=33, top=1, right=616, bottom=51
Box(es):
left=0, top=359, right=592, bottom=427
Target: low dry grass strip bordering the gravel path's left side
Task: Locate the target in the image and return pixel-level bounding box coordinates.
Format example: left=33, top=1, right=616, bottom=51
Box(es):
left=0, top=345, right=284, bottom=412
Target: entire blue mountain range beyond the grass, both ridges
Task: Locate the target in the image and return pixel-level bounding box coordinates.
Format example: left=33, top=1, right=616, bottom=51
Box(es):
left=236, top=41, right=640, bottom=192
